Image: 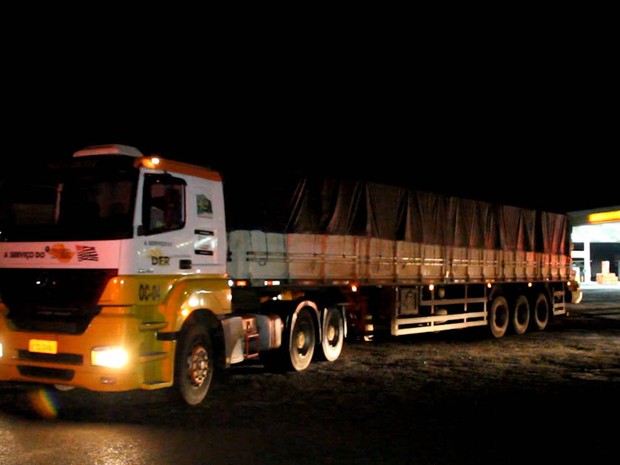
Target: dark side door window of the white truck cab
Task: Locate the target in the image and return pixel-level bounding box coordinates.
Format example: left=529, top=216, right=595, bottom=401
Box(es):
left=142, top=174, right=185, bottom=234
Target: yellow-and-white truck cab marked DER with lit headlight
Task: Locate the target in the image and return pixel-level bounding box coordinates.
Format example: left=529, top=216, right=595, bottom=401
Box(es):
left=0, top=145, right=234, bottom=399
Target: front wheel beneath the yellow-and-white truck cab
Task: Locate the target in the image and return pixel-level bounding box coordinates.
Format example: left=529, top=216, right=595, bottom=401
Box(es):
left=174, top=325, right=215, bottom=405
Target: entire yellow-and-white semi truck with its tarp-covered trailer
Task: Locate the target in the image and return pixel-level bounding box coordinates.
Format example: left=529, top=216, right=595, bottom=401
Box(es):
left=0, top=144, right=580, bottom=406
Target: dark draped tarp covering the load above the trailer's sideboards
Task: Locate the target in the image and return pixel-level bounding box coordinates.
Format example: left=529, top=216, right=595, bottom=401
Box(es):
left=225, top=178, right=570, bottom=255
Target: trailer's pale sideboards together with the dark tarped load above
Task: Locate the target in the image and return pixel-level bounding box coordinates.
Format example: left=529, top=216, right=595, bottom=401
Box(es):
left=227, top=179, right=570, bottom=284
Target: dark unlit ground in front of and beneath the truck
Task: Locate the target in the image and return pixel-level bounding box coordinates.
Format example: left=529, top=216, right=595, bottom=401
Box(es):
left=0, top=287, right=620, bottom=465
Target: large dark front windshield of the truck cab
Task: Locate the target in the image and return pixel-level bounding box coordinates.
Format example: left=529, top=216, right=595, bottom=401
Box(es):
left=0, top=157, right=138, bottom=242
